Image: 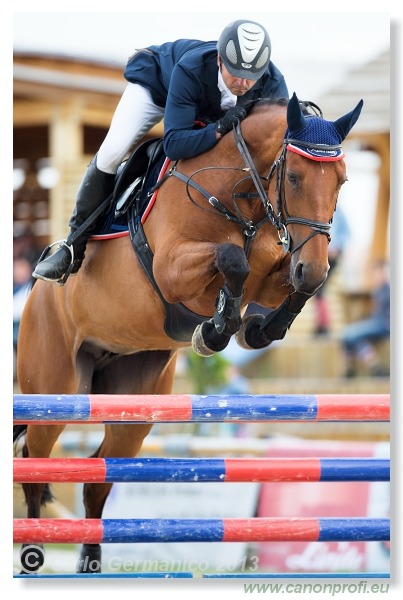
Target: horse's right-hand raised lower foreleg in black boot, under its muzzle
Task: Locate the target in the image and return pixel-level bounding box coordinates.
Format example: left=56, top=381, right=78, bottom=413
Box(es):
left=236, top=292, right=311, bottom=350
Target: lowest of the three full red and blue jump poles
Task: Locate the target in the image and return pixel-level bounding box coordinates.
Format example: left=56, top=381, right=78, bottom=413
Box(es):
left=14, top=517, right=390, bottom=544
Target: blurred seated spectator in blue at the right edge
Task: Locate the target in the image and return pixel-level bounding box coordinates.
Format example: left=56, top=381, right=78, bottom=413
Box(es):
left=341, top=261, right=390, bottom=377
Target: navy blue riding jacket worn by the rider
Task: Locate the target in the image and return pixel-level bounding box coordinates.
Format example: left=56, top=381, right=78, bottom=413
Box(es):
left=124, top=40, right=288, bottom=160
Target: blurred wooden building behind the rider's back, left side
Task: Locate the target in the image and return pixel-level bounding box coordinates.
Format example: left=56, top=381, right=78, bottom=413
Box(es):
left=14, top=52, right=162, bottom=246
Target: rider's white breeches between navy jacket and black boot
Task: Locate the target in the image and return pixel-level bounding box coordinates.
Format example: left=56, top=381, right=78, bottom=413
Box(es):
left=97, top=83, right=164, bottom=174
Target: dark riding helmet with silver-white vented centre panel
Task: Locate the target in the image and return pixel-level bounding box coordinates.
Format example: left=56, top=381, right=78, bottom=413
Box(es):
left=217, top=20, right=271, bottom=79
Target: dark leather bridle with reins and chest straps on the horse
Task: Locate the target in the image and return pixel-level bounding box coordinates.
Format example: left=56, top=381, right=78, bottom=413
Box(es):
left=159, top=117, right=341, bottom=256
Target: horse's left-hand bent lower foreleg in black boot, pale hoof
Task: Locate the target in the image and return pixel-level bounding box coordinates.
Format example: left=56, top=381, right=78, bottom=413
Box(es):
left=192, top=244, right=249, bottom=356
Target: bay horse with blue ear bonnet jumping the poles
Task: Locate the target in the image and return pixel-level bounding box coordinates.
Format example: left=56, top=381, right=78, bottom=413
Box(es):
left=14, top=94, right=363, bottom=573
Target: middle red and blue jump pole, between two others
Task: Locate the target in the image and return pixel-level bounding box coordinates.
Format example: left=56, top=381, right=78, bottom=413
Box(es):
left=14, top=458, right=390, bottom=483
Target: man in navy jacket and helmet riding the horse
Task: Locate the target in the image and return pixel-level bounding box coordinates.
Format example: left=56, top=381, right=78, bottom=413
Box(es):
left=33, top=19, right=288, bottom=285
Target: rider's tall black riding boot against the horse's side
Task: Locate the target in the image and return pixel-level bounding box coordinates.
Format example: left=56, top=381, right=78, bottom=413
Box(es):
left=33, top=157, right=115, bottom=285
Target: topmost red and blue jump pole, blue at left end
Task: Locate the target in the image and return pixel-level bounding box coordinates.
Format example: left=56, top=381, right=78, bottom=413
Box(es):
left=14, top=394, right=390, bottom=424
